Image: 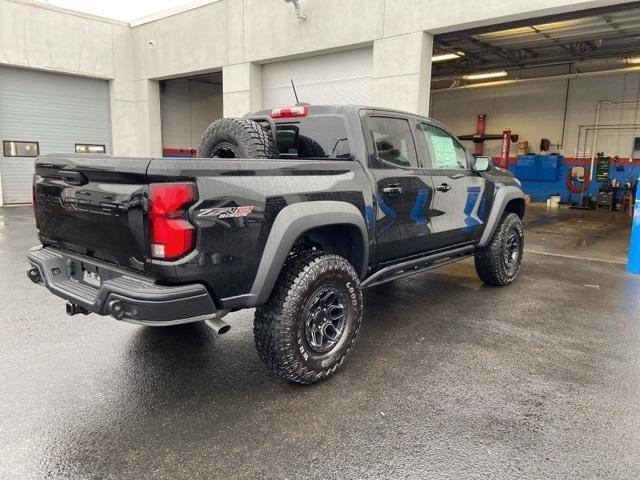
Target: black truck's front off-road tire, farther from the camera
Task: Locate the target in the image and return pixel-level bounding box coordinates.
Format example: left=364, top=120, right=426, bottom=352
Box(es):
left=475, top=212, right=524, bottom=287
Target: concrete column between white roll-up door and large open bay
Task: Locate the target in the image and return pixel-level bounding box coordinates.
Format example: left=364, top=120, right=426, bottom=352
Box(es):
left=371, top=32, right=433, bottom=116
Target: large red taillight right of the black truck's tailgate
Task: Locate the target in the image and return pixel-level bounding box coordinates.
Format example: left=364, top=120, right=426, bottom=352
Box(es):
left=149, top=183, right=196, bottom=260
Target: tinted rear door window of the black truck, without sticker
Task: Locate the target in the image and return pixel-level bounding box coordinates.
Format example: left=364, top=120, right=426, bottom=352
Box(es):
left=369, top=117, right=419, bottom=167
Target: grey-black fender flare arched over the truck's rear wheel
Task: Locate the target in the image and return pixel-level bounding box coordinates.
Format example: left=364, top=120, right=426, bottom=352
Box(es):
left=249, top=200, right=369, bottom=305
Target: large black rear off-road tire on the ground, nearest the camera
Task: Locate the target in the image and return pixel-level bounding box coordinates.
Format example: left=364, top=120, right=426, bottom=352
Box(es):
left=253, top=253, right=363, bottom=384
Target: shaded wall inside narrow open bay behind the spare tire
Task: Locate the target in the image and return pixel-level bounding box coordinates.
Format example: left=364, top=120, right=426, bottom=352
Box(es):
left=160, top=79, right=222, bottom=149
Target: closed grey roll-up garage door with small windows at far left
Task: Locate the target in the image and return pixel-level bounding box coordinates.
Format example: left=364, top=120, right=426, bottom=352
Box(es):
left=0, top=67, right=111, bottom=204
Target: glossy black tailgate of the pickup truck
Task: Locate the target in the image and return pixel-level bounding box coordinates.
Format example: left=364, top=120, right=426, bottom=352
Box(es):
left=33, top=155, right=150, bottom=270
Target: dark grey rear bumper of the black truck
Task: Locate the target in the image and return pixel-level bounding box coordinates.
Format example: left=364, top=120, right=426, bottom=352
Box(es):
left=27, top=247, right=221, bottom=325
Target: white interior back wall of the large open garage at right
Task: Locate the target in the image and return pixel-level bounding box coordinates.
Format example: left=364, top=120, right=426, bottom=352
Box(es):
left=431, top=73, right=640, bottom=157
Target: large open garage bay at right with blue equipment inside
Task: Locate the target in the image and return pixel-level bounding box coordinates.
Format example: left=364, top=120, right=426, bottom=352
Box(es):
left=431, top=2, right=640, bottom=261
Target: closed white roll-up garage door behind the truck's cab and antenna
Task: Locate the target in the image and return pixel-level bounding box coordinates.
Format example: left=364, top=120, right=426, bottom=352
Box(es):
left=262, top=48, right=373, bottom=108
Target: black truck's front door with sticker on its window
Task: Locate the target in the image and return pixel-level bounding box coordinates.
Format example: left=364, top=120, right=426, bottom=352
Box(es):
left=417, top=122, right=492, bottom=248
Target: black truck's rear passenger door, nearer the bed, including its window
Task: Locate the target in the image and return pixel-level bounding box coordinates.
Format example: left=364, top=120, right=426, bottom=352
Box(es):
left=365, top=113, right=433, bottom=261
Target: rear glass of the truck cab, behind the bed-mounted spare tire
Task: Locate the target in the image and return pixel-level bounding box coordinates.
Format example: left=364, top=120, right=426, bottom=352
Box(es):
left=276, top=115, right=351, bottom=159
